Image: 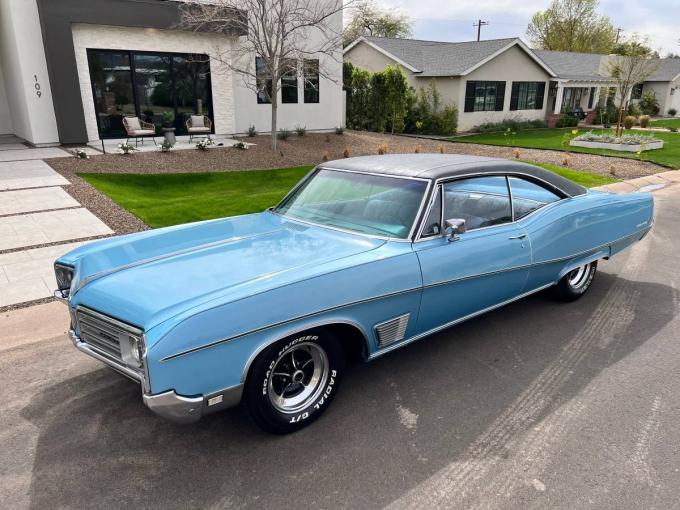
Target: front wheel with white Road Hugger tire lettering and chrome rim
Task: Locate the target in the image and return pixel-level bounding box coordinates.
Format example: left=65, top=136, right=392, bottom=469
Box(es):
left=244, top=331, right=345, bottom=434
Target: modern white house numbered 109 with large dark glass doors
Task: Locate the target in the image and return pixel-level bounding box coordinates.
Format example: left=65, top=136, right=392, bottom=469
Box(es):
left=0, top=0, right=343, bottom=146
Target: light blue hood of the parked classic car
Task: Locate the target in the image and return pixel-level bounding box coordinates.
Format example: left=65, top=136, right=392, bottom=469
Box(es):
left=70, top=213, right=385, bottom=330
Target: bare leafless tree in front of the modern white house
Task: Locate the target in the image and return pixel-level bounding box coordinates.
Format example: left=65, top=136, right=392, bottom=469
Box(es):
left=180, top=0, right=347, bottom=149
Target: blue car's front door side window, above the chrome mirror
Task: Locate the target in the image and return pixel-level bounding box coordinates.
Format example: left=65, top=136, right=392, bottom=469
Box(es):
left=444, top=175, right=512, bottom=230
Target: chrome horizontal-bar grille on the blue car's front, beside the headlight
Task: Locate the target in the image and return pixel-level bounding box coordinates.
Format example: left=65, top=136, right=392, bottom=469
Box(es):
left=76, top=307, right=141, bottom=360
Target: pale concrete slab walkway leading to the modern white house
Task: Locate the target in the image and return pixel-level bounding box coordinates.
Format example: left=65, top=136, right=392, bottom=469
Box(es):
left=0, top=137, right=113, bottom=308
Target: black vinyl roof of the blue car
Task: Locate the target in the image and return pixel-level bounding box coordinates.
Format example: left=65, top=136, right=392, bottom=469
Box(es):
left=319, top=154, right=586, bottom=197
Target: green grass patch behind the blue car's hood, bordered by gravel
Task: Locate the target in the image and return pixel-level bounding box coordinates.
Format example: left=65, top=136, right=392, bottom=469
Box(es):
left=78, top=166, right=313, bottom=227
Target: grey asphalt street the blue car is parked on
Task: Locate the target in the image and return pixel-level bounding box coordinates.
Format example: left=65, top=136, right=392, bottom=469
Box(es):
left=0, top=184, right=680, bottom=509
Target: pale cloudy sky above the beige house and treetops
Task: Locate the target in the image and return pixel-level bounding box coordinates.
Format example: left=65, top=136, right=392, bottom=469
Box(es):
left=376, top=0, right=680, bottom=56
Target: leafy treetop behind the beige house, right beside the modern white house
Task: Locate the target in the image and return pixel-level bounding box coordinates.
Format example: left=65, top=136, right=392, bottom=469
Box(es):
left=342, top=0, right=413, bottom=46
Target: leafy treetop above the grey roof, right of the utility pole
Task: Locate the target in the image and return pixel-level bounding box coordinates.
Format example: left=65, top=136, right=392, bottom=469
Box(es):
left=527, top=0, right=616, bottom=54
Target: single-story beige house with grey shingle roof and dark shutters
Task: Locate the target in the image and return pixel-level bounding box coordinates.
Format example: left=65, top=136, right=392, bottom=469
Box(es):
left=344, top=37, right=680, bottom=131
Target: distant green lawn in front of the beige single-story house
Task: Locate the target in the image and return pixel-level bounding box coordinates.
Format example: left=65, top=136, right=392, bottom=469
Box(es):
left=450, top=128, right=680, bottom=168
